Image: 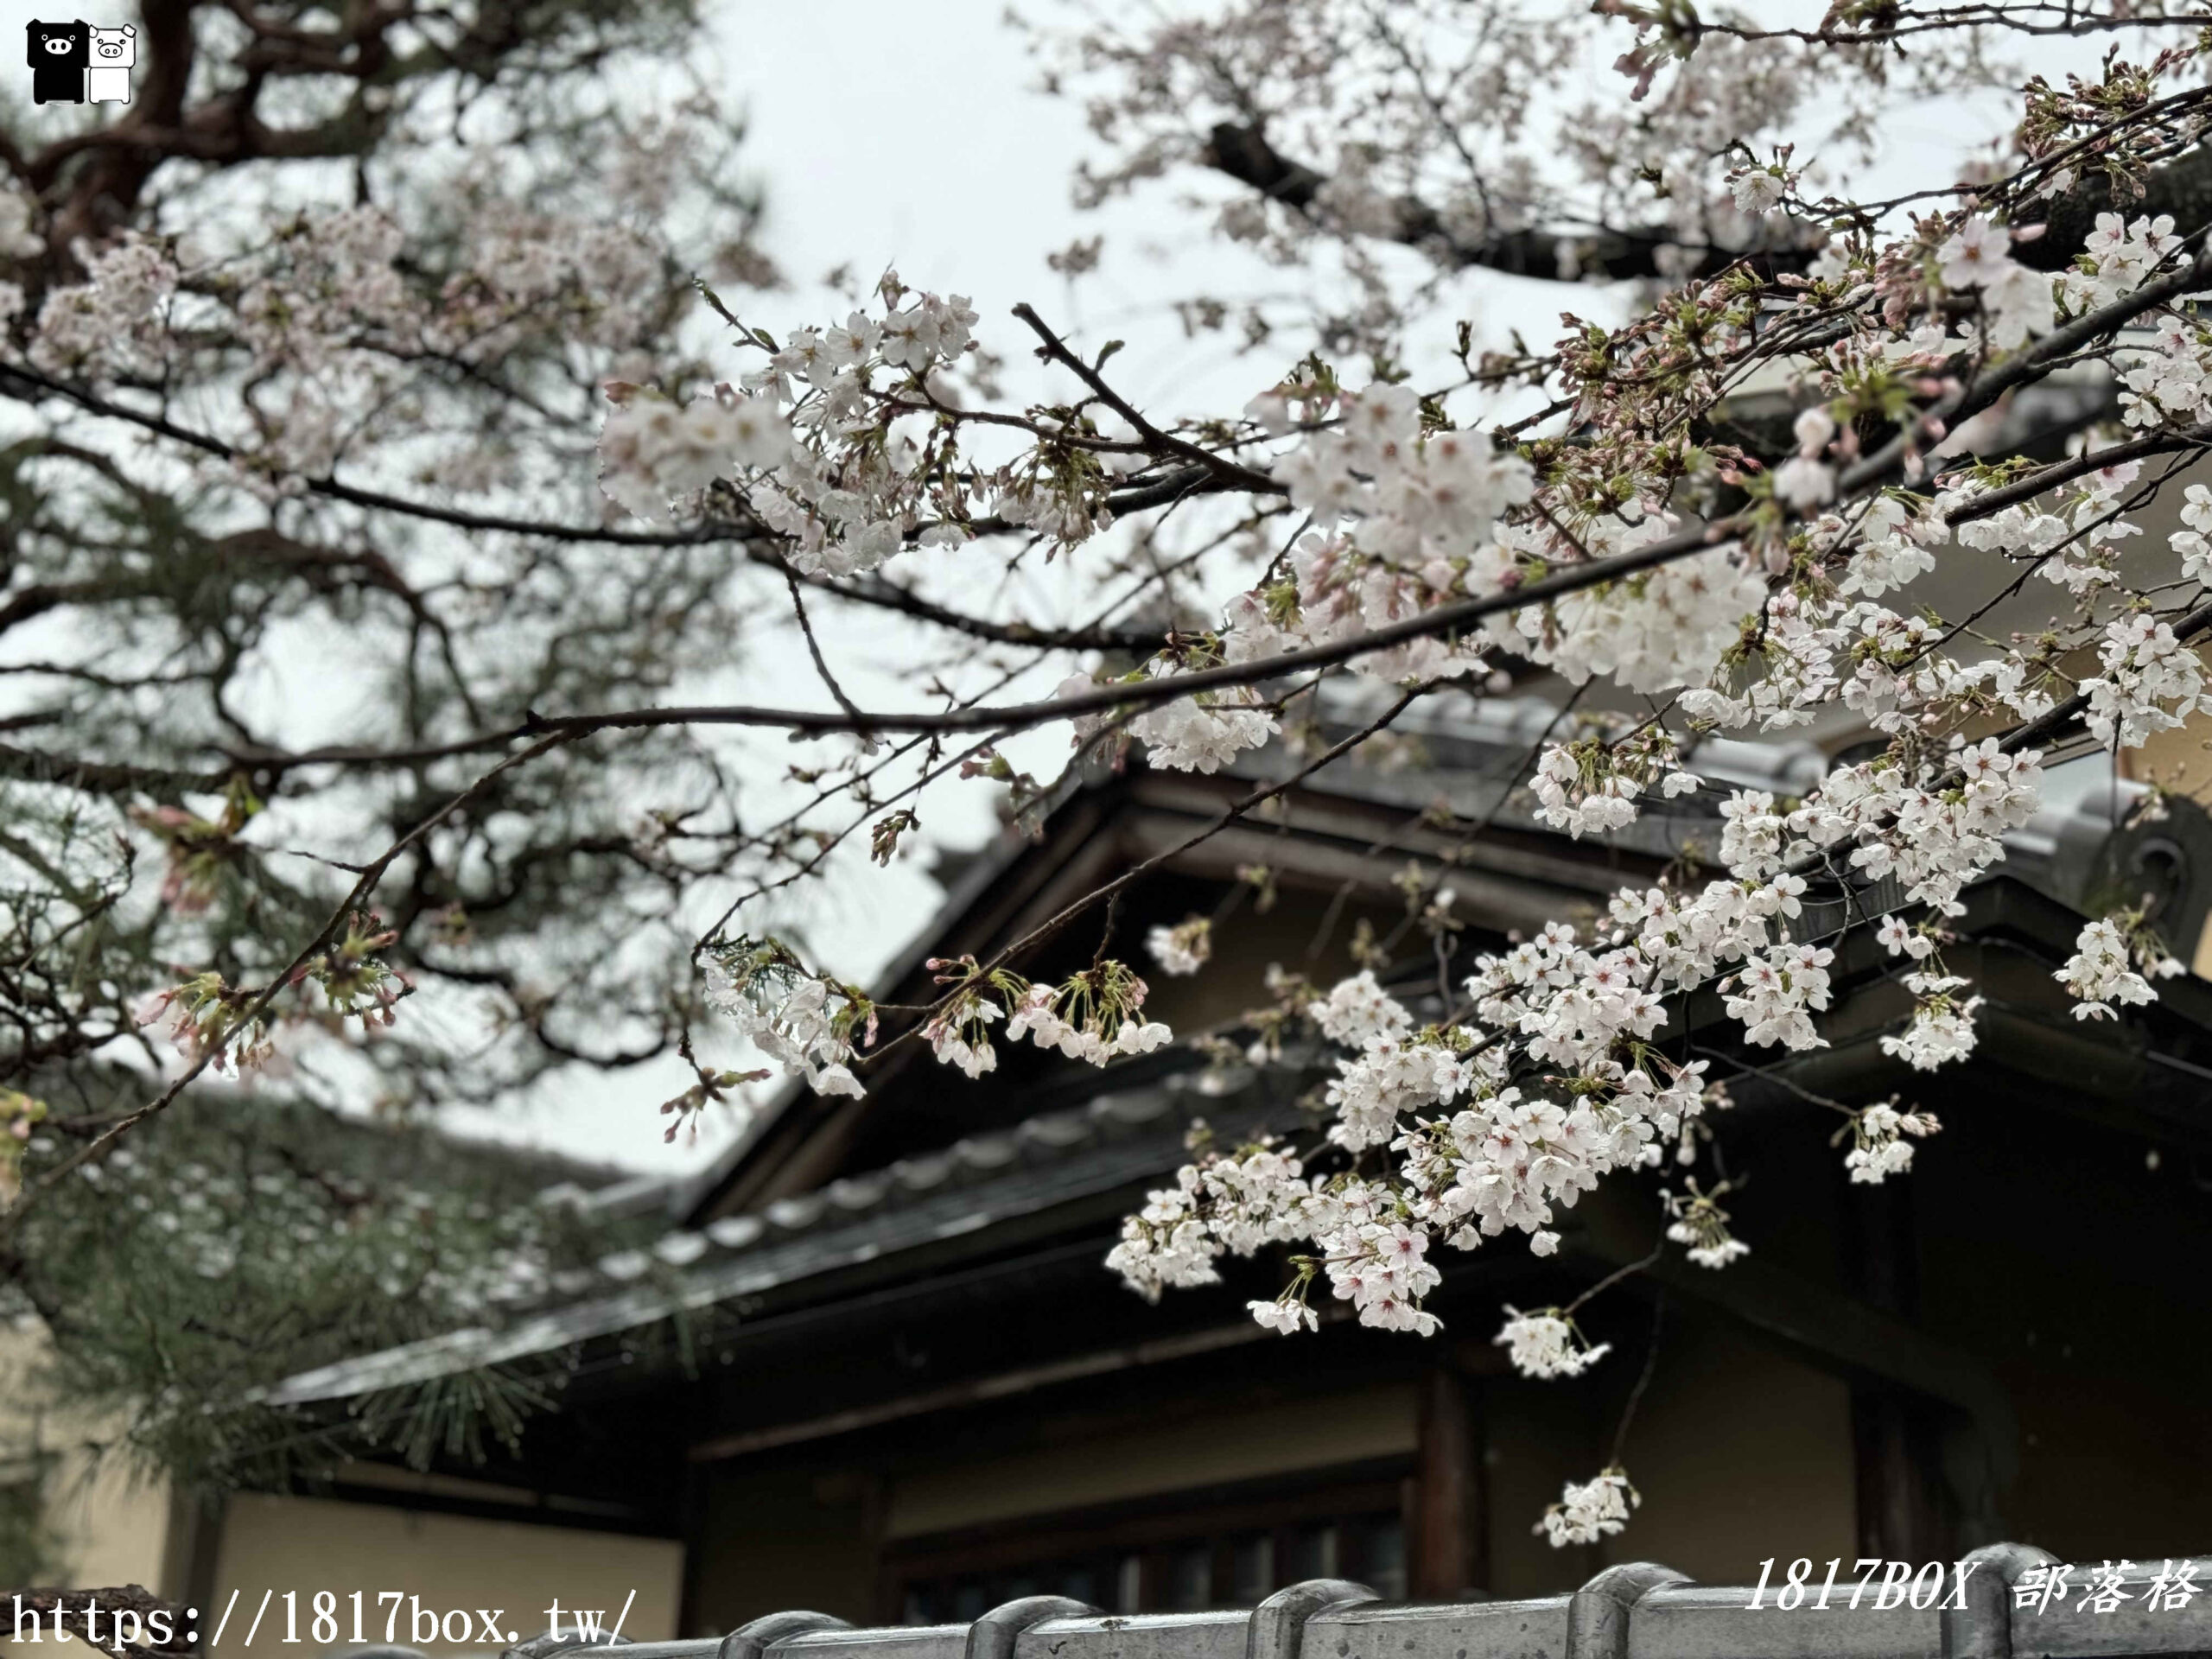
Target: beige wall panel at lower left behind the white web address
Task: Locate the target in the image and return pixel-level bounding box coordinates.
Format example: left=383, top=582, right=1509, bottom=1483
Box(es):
left=204, top=1493, right=683, bottom=1659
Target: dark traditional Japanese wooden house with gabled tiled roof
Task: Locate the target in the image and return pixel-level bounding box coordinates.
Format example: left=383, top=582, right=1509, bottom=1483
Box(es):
left=219, top=677, right=2212, bottom=1635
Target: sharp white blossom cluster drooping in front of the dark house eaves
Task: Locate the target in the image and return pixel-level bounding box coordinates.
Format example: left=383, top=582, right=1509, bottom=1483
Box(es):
left=1113, top=677, right=2039, bottom=1537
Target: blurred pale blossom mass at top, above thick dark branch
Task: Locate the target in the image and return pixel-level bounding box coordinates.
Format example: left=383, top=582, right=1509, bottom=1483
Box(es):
left=1035, top=0, right=1885, bottom=318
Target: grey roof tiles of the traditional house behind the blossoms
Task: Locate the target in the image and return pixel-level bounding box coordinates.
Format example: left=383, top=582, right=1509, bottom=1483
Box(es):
left=270, top=696, right=2212, bottom=1405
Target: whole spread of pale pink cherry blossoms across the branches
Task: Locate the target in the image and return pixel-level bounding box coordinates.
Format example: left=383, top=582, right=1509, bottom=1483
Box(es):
left=17, top=0, right=2212, bottom=1544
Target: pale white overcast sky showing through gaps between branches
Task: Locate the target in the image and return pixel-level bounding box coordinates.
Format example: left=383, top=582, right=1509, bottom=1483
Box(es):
left=0, top=0, right=2035, bottom=1170
